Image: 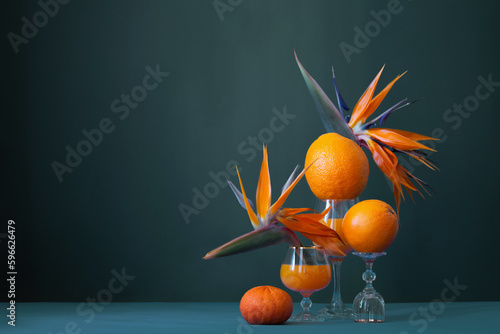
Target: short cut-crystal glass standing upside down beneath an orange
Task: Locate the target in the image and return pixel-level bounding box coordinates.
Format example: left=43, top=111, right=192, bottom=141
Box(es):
left=352, top=252, right=387, bottom=322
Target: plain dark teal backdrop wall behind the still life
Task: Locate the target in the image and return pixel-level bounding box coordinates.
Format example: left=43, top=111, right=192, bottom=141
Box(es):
left=0, top=0, right=500, bottom=302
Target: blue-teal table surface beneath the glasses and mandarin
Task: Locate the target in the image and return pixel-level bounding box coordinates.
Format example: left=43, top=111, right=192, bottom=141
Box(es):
left=0, top=302, right=500, bottom=334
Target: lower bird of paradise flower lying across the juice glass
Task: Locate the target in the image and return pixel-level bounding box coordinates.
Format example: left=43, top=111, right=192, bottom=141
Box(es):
left=203, top=146, right=345, bottom=259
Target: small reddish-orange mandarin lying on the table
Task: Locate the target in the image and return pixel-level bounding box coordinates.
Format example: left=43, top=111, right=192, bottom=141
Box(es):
left=240, top=285, right=293, bottom=325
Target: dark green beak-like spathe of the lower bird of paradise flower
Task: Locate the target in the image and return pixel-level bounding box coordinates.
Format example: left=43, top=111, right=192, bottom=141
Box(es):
left=203, top=224, right=300, bottom=260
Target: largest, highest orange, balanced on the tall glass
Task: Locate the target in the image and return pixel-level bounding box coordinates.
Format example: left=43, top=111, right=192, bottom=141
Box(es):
left=305, top=133, right=369, bottom=200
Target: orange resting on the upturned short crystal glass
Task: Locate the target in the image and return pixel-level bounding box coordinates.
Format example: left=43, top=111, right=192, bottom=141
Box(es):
left=342, top=199, right=399, bottom=253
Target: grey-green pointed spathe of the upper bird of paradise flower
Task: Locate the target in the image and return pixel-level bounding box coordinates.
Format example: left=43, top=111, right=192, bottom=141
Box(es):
left=295, top=53, right=358, bottom=142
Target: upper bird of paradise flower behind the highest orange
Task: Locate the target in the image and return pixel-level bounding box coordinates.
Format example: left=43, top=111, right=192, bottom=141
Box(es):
left=295, top=53, right=437, bottom=212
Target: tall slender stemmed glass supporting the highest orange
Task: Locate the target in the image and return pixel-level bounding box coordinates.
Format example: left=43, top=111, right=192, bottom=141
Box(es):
left=316, top=198, right=359, bottom=319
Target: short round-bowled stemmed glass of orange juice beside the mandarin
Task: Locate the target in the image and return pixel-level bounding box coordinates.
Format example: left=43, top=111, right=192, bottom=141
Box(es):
left=280, top=246, right=332, bottom=322
